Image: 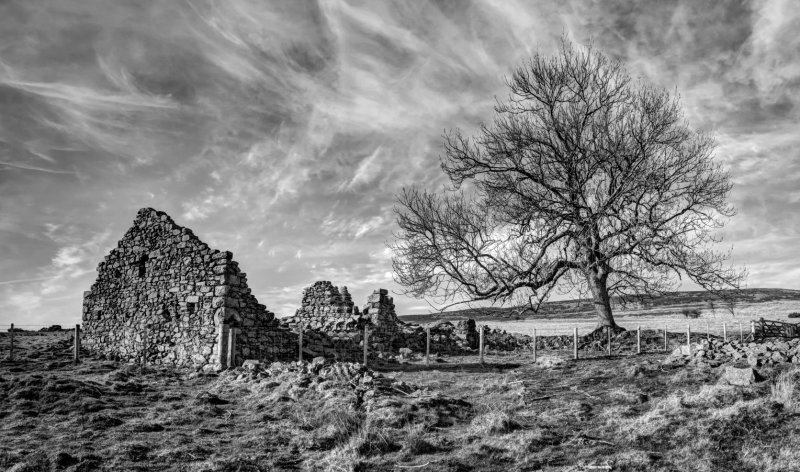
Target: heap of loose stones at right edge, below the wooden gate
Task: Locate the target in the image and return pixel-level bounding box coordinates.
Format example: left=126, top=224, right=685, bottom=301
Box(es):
left=668, top=338, right=800, bottom=368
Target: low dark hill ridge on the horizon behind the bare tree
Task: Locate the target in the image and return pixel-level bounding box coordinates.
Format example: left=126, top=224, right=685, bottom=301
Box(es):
left=400, top=288, right=800, bottom=322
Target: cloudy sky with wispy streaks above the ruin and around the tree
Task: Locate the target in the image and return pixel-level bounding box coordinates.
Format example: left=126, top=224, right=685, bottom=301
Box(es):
left=0, top=0, right=800, bottom=325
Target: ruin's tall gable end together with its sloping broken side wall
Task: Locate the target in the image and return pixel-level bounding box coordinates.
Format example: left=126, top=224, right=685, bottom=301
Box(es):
left=83, top=208, right=296, bottom=367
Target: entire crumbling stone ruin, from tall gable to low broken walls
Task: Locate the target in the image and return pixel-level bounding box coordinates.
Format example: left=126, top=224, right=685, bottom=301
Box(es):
left=83, top=208, right=494, bottom=369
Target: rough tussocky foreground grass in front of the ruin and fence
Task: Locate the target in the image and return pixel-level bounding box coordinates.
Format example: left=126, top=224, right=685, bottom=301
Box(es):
left=0, top=333, right=800, bottom=472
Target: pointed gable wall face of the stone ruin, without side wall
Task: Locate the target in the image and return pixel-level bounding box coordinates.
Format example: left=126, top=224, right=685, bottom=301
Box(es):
left=83, top=208, right=231, bottom=365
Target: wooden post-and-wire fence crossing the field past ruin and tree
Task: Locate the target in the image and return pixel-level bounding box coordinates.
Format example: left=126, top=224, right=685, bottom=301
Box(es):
left=0, top=319, right=768, bottom=368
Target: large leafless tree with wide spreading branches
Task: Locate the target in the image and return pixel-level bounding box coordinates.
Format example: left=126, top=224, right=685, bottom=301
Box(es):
left=392, top=39, right=745, bottom=328
